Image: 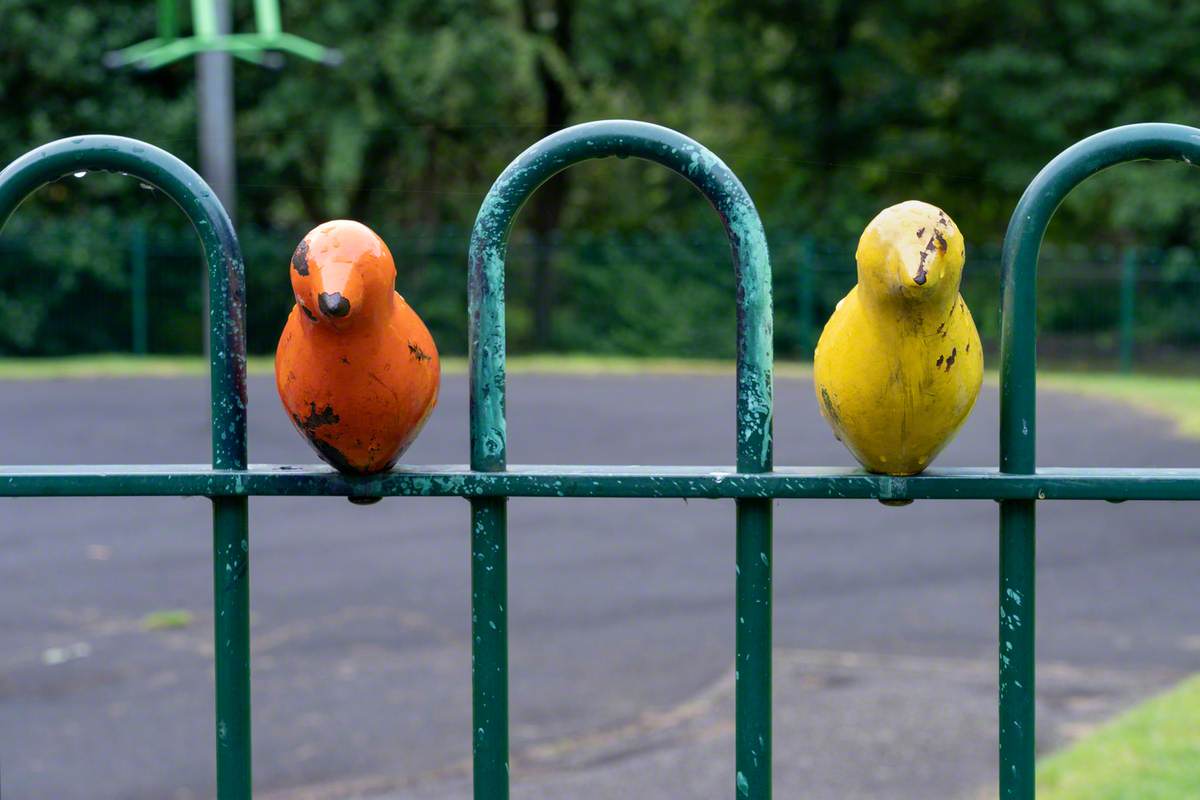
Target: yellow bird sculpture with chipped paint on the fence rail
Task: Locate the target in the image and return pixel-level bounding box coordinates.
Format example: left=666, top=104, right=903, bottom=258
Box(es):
left=812, top=200, right=983, bottom=475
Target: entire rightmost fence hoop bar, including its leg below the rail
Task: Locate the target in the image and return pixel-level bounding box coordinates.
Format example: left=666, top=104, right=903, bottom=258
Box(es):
left=1000, top=122, right=1200, bottom=800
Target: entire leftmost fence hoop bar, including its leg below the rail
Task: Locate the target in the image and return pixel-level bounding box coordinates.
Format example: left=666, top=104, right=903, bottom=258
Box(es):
left=0, top=136, right=252, bottom=800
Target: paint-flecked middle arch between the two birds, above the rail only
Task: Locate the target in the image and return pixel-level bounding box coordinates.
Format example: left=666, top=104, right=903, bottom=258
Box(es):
left=468, top=120, right=774, bottom=473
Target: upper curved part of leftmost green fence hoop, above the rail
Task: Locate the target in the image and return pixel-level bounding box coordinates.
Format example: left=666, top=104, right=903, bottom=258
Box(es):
left=0, top=136, right=247, bottom=469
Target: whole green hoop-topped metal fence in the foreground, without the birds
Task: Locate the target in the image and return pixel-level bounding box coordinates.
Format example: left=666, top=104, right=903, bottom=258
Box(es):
left=0, top=121, right=1200, bottom=800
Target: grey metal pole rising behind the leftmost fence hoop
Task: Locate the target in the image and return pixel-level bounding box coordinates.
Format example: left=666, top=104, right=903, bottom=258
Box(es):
left=193, top=0, right=238, bottom=353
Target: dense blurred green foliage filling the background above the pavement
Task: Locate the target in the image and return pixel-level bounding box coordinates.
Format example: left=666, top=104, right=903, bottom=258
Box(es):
left=0, top=0, right=1200, bottom=355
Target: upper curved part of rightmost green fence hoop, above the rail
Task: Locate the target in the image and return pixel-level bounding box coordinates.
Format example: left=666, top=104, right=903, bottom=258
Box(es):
left=1000, top=122, right=1200, bottom=473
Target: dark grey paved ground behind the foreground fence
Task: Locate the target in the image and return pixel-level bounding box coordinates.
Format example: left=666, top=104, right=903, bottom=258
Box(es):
left=0, top=375, right=1200, bottom=800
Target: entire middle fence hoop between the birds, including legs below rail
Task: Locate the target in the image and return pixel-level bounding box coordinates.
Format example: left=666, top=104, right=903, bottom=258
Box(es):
left=468, top=120, right=773, bottom=800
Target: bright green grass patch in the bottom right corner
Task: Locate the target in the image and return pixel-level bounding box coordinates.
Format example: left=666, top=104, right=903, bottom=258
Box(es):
left=1037, top=676, right=1200, bottom=800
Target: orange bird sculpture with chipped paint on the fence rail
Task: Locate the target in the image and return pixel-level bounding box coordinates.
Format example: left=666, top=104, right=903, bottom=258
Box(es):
left=275, top=219, right=442, bottom=475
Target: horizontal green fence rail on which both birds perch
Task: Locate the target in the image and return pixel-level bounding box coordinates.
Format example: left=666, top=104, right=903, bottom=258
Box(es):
left=0, top=464, right=1200, bottom=501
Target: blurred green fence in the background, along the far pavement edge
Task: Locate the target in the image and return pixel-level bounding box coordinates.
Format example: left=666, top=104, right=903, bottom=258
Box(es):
left=0, top=217, right=1200, bottom=369
